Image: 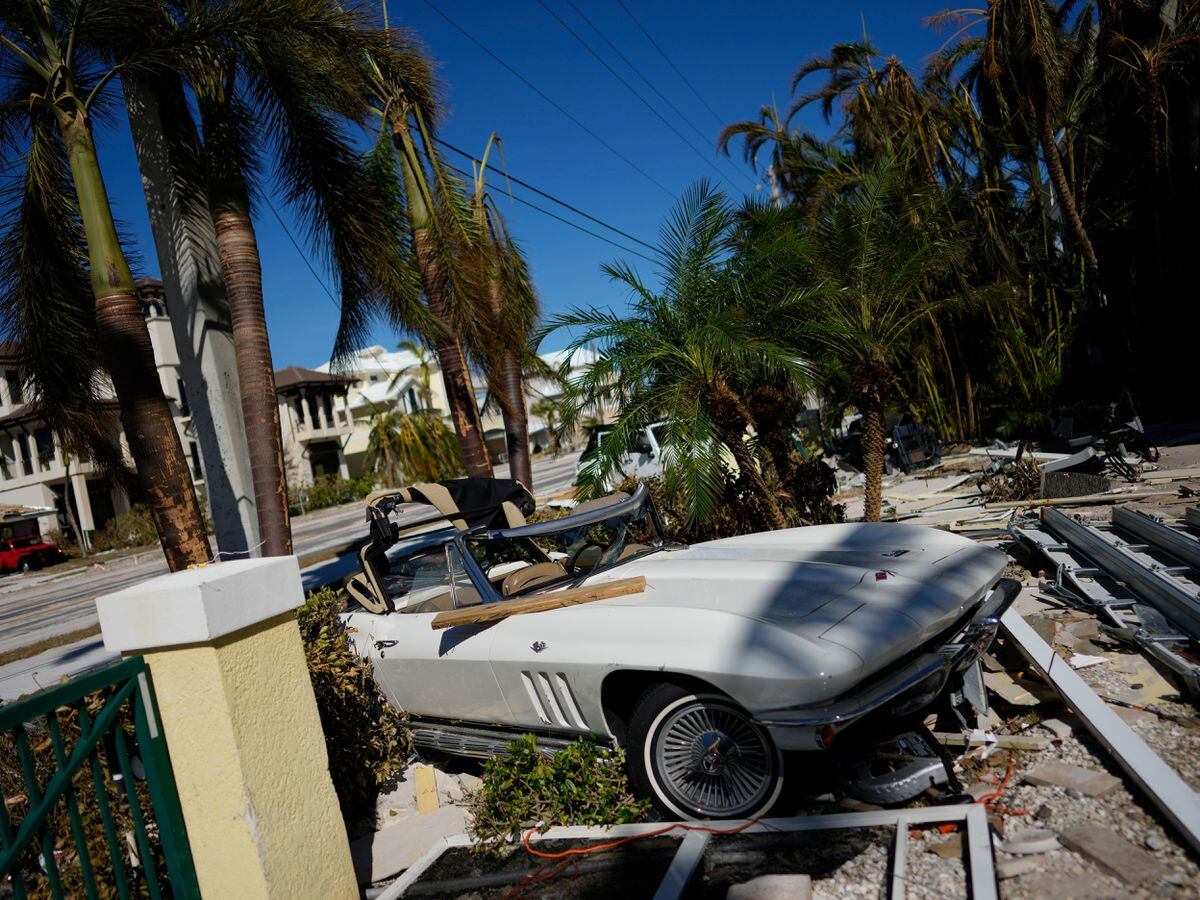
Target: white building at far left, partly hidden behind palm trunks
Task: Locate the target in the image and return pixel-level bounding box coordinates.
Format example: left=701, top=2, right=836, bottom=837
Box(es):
left=0, top=278, right=204, bottom=547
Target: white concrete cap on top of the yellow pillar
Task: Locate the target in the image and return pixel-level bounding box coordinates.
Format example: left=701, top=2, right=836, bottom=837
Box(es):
left=96, top=557, right=304, bottom=653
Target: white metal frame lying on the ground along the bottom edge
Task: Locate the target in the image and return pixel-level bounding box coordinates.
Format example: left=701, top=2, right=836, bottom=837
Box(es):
left=377, top=806, right=998, bottom=900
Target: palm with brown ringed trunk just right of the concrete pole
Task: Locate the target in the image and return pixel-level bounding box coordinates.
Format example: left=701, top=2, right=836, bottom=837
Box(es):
left=151, top=0, right=428, bottom=556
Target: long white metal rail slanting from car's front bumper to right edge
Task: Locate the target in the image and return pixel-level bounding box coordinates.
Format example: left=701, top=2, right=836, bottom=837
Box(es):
left=1000, top=610, right=1200, bottom=852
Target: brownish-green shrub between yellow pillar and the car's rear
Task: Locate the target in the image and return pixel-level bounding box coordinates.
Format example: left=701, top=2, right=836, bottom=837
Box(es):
left=296, top=588, right=413, bottom=833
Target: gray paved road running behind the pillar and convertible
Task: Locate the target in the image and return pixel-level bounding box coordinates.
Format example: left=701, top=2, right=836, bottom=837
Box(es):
left=0, top=454, right=578, bottom=662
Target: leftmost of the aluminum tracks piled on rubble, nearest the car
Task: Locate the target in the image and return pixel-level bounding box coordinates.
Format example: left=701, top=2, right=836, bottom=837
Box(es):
left=1009, top=513, right=1200, bottom=697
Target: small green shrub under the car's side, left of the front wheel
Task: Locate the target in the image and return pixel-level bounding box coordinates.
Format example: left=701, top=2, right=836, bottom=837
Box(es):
left=470, top=734, right=649, bottom=851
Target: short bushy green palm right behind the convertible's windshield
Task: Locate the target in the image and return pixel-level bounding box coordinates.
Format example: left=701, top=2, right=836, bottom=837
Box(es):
left=542, top=182, right=806, bottom=528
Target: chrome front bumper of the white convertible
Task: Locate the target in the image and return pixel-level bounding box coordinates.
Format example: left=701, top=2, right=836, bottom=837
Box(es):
left=755, top=578, right=1021, bottom=750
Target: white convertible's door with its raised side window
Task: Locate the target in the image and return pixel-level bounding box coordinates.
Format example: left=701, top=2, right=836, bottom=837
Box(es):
left=348, top=544, right=511, bottom=724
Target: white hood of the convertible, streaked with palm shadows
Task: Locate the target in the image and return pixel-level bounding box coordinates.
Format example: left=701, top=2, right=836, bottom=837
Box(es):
left=589, top=523, right=1006, bottom=676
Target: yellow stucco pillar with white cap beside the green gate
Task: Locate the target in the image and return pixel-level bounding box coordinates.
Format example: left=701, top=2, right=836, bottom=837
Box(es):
left=96, top=557, right=359, bottom=900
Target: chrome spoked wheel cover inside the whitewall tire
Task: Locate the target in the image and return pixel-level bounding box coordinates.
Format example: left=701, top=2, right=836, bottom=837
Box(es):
left=654, top=698, right=779, bottom=818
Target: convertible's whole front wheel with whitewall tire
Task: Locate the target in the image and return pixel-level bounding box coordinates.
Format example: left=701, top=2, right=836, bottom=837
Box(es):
left=626, top=684, right=784, bottom=818
